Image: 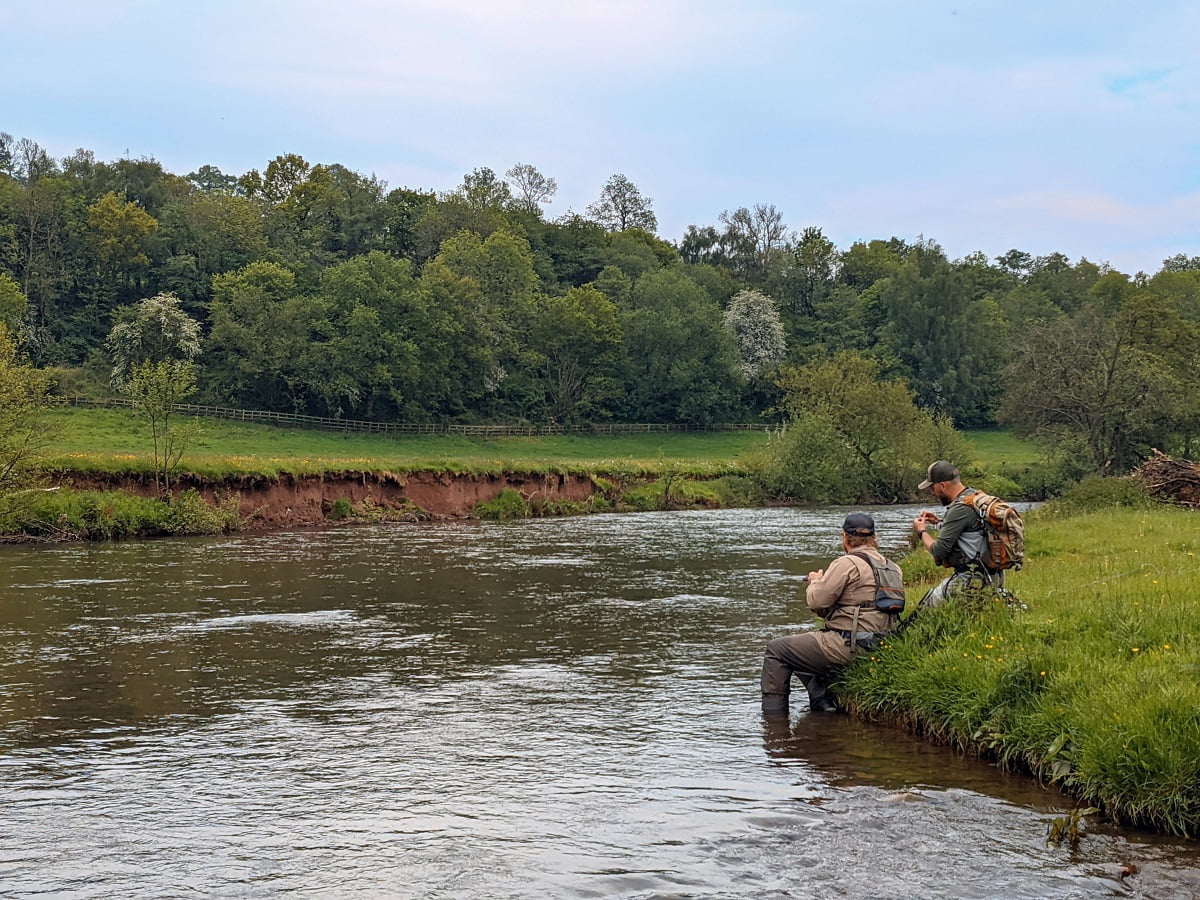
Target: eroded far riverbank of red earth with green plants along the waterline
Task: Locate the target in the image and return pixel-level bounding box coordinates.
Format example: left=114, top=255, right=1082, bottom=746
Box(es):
left=0, top=466, right=750, bottom=542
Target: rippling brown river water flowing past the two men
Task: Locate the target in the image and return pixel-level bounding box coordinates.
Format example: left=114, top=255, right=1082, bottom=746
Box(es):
left=0, top=508, right=1200, bottom=898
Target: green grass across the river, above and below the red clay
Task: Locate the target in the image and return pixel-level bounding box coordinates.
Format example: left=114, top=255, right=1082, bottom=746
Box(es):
left=0, top=408, right=1051, bottom=540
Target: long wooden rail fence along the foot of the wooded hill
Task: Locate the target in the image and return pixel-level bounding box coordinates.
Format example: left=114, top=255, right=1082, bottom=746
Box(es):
left=56, top=397, right=779, bottom=438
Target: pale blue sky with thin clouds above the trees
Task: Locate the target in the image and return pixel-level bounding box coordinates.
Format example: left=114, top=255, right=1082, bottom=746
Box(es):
left=0, top=0, right=1200, bottom=275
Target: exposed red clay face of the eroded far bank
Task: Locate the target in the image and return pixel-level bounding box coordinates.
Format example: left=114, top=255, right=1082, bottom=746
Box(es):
left=56, top=472, right=599, bottom=529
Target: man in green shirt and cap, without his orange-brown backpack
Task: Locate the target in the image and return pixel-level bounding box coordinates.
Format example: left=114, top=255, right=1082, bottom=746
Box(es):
left=912, top=460, right=1004, bottom=606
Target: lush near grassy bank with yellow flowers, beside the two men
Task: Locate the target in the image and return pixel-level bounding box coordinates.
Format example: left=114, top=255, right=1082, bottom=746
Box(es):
left=844, top=506, right=1200, bottom=835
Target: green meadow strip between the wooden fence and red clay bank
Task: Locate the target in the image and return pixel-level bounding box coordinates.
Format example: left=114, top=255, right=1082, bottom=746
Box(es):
left=43, top=409, right=766, bottom=478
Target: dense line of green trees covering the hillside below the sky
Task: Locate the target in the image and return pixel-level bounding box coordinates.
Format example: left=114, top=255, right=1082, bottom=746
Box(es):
left=0, top=133, right=1200, bottom=472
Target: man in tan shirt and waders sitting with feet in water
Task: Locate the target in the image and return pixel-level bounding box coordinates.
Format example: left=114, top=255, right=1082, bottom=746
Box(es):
left=762, top=512, right=902, bottom=714
